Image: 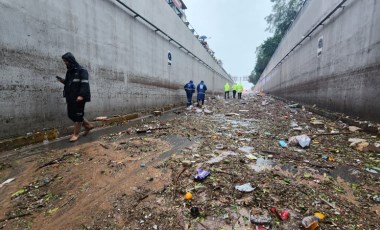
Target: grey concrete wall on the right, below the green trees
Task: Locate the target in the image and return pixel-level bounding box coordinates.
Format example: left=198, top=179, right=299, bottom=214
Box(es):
left=255, top=0, right=380, bottom=121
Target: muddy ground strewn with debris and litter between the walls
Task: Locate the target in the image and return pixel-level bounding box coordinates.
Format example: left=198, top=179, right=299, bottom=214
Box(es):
left=0, top=95, right=380, bottom=230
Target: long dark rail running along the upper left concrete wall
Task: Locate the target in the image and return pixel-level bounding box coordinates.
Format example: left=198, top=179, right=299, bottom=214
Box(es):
left=116, top=0, right=232, bottom=81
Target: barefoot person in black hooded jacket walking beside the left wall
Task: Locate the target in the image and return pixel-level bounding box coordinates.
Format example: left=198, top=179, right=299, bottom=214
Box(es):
left=57, top=52, right=94, bottom=142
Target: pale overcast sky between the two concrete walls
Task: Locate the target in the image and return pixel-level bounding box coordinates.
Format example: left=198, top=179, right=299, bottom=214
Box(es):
left=183, top=0, right=272, bottom=77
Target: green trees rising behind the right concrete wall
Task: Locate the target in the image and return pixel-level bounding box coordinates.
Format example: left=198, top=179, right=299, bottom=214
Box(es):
left=249, top=0, right=306, bottom=84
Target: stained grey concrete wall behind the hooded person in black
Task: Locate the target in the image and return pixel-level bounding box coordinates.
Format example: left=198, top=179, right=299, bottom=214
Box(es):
left=0, top=0, right=231, bottom=137
